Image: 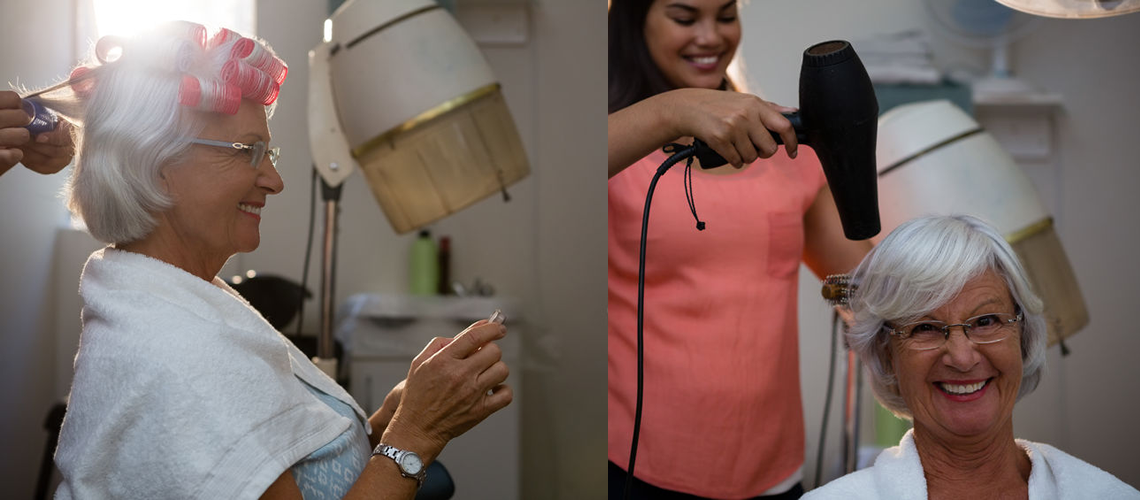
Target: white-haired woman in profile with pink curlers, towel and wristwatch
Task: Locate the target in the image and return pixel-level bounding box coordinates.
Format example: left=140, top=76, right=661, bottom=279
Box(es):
left=41, top=23, right=512, bottom=499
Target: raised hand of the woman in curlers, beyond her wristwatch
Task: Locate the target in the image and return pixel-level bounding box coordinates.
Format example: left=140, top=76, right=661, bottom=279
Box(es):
left=381, top=320, right=513, bottom=464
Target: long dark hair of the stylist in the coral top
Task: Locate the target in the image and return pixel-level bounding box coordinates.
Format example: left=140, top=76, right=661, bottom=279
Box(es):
left=609, top=0, right=735, bottom=113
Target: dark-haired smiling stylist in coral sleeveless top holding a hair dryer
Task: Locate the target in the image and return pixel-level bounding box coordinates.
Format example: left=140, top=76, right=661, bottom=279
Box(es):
left=609, top=0, right=871, bottom=499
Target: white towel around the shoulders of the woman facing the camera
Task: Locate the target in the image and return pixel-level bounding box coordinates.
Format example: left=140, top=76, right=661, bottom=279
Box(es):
left=803, top=429, right=1140, bottom=500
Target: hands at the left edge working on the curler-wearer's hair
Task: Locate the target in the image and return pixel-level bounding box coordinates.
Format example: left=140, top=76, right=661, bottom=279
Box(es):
left=0, top=90, right=74, bottom=174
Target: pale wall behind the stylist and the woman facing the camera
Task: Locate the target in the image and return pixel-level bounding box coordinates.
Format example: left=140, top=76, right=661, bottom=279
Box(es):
left=741, top=0, right=1140, bottom=492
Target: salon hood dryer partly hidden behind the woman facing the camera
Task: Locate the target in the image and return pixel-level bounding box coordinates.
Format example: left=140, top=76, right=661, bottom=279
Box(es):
left=873, top=100, right=1089, bottom=345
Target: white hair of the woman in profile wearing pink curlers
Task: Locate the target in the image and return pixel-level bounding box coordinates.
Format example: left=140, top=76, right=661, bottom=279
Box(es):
left=41, top=22, right=284, bottom=244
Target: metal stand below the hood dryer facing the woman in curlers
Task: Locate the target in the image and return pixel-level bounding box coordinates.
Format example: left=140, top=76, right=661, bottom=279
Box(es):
left=312, top=177, right=343, bottom=380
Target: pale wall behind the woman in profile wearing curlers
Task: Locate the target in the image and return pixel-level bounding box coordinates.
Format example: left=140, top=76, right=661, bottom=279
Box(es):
left=0, top=0, right=605, bottom=499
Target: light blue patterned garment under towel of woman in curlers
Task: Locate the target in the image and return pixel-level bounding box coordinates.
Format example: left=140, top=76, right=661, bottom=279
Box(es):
left=293, top=379, right=372, bottom=500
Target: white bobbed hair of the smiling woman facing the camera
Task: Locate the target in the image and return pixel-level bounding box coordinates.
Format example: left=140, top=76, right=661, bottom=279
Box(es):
left=846, top=215, right=1047, bottom=419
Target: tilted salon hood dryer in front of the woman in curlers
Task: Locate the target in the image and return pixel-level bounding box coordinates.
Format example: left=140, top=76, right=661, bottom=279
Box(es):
left=309, top=0, right=530, bottom=233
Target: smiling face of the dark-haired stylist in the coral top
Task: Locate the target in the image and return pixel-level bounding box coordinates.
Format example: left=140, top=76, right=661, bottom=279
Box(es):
left=645, top=0, right=740, bottom=89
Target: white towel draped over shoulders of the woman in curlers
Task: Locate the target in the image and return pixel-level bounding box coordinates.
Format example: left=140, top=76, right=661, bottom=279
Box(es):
left=56, top=247, right=371, bottom=499
